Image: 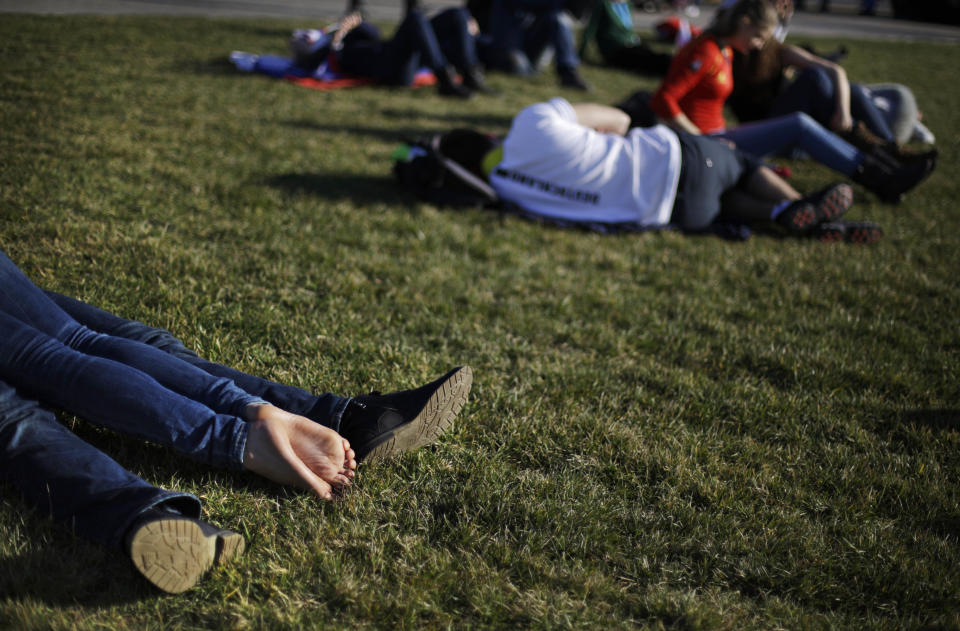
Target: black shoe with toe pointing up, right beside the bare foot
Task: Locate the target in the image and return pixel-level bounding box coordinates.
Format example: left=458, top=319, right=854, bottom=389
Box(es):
left=340, top=366, right=473, bottom=462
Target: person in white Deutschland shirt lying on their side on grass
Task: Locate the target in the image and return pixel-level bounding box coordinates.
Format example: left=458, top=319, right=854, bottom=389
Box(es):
left=439, top=98, right=882, bottom=243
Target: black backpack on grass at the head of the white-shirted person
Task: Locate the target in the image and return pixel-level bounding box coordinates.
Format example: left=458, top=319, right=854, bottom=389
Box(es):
left=392, top=134, right=500, bottom=208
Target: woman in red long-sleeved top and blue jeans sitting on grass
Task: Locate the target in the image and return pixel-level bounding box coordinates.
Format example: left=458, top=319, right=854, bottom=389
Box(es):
left=650, top=0, right=936, bottom=203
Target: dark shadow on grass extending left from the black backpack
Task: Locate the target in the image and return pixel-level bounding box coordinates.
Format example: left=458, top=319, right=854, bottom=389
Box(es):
left=266, top=173, right=404, bottom=206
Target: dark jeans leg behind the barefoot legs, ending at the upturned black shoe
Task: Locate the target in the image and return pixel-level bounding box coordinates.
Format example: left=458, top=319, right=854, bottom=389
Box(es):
left=44, top=290, right=349, bottom=431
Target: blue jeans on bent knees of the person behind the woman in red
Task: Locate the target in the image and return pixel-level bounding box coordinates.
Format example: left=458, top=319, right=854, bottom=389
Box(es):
left=770, top=68, right=894, bottom=142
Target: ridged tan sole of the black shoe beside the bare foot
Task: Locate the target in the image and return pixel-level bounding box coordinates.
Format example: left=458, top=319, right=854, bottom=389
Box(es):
left=357, top=366, right=473, bottom=464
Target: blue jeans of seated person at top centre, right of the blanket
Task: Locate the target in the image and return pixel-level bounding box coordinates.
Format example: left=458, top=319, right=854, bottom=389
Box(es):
left=481, top=0, right=580, bottom=74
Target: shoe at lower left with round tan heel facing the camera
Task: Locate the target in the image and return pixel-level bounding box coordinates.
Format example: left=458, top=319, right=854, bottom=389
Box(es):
left=126, top=509, right=246, bottom=594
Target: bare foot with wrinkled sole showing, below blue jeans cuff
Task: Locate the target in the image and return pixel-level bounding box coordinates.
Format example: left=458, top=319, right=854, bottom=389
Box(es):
left=243, top=405, right=357, bottom=500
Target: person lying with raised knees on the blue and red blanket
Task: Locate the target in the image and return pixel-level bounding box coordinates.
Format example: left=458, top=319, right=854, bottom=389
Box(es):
left=291, top=8, right=488, bottom=98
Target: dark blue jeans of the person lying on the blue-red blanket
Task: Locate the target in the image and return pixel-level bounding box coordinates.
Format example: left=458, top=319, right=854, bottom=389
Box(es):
left=337, top=11, right=476, bottom=85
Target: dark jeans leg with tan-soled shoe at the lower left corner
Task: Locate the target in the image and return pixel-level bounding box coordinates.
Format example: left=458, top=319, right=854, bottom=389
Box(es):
left=0, top=382, right=244, bottom=593
